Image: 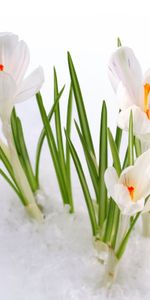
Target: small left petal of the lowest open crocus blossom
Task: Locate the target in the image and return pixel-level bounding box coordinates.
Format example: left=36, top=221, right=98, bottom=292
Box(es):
left=104, top=167, right=118, bottom=199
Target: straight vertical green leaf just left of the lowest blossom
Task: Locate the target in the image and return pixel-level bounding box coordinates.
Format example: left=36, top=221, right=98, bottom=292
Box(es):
left=99, top=101, right=108, bottom=228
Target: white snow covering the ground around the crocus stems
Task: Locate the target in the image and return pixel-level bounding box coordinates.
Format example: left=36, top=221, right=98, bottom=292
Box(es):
left=0, top=175, right=150, bottom=300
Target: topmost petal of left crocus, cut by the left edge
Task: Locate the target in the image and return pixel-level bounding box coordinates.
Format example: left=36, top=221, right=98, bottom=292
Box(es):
left=0, top=33, right=18, bottom=67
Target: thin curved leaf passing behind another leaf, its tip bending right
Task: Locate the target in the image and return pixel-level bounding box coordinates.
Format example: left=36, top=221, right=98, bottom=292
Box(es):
left=35, top=86, right=65, bottom=184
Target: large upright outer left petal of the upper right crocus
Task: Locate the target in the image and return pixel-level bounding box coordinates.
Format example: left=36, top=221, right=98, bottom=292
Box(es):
left=109, top=47, right=143, bottom=104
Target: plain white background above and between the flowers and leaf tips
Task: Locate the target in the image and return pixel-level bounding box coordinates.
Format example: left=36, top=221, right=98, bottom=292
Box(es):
left=0, top=0, right=150, bottom=152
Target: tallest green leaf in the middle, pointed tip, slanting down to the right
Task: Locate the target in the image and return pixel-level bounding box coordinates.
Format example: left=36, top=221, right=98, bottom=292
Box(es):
left=68, top=52, right=95, bottom=156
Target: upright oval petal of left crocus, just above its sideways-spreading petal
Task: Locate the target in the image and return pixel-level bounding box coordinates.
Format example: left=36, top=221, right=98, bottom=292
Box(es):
left=8, top=41, right=30, bottom=84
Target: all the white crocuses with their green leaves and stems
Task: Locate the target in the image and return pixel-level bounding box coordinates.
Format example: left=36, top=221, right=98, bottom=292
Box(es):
left=0, top=33, right=150, bottom=283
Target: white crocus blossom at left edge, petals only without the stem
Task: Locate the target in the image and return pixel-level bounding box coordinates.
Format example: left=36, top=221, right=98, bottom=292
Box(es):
left=0, top=33, right=44, bottom=119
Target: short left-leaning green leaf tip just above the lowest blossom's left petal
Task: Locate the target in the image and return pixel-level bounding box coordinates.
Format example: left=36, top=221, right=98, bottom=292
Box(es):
left=108, top=128, right=121, bottom=176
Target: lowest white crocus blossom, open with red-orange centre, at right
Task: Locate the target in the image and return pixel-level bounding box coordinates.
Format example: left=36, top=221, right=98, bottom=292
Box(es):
left=104, top=150, right=150, bottom=216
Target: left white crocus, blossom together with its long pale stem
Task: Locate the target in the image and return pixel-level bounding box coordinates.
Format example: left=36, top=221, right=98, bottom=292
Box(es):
left=0, top=33, right=44, bottom=220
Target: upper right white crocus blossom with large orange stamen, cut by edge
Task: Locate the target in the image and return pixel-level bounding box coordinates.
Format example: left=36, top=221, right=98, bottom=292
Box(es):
left=109, top=47, right=150, bottom=141
